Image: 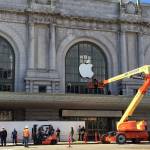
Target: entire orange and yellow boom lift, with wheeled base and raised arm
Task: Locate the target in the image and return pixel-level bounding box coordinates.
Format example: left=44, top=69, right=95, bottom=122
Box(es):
left=99, top=65, right=150, bottom=144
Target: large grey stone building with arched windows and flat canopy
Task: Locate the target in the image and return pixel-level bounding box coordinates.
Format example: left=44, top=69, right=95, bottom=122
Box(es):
left=0, top=0, right=150, bottom=138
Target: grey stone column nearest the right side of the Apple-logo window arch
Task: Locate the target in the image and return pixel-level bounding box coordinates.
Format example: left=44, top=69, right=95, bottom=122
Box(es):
left=120, top=31, right=128, bottom=73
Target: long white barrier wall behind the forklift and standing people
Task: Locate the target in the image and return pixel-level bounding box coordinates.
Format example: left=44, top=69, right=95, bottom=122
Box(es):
left=0, top=121, right=85, bottom=142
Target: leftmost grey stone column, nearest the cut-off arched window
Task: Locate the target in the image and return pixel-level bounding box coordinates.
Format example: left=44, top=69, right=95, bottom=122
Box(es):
left=28, top=23, right=35, bottom=69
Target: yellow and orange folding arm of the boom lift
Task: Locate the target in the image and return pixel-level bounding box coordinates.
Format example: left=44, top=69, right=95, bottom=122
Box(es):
left=101, top=65, right=150, bottom=131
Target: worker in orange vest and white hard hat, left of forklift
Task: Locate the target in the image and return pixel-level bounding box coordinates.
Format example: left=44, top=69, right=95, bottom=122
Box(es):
left=23, top=126, right=30, bottom=147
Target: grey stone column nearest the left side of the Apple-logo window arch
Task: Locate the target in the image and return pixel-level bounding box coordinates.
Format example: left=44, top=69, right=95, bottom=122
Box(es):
left=49, top=24, right=56, bottom=70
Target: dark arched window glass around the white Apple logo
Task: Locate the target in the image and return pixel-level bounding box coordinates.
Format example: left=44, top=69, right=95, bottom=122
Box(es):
left=65, top=42, right=107, bottom=93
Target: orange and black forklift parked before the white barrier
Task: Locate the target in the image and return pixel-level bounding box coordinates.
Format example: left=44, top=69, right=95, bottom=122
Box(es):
left=32, top=124, right=57, bottom=145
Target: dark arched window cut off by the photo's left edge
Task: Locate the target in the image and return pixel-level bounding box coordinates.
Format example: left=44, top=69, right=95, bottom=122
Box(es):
left=0, top=37, right=15, bottom=91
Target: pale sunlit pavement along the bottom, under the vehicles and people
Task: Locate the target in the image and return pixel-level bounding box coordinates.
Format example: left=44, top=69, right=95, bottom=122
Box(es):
left=0, top=142, right=150, bottom=150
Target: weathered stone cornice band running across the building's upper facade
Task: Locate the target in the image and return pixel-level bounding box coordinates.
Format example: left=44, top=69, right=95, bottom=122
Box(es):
left=0, top=5, right=150, bottom=34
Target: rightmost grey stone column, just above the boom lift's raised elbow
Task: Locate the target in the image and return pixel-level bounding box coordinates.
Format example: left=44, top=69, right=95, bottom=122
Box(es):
left=137, top=33, right=144, bottom=66
